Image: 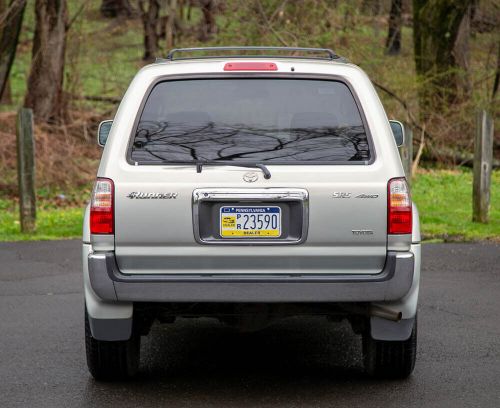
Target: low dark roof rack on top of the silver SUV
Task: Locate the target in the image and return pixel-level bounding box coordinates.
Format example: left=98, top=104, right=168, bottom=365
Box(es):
left=167, top=46, right=342, bottom=61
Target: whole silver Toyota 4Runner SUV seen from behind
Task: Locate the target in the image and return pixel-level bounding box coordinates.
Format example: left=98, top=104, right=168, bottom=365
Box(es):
left=83, top=47, right=420, bottom=380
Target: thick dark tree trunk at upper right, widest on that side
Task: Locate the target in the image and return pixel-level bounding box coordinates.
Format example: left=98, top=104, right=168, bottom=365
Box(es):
left=413, top=0, right=474, bottom=121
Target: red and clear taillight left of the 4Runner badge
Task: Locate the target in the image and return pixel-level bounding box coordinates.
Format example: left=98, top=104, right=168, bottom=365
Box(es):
left=90, top=178, right=114, bottom=234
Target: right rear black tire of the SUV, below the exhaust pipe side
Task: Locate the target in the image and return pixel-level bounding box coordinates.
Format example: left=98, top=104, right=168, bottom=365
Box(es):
left=363, top=317, right=417, bottom=379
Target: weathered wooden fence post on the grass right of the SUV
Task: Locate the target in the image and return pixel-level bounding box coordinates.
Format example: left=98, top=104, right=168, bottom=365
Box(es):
left=472, top=110, right=493, bottom=223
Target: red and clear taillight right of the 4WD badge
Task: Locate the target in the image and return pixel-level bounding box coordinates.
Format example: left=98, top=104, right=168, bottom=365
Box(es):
left=387, top=178, right=412, bottom=234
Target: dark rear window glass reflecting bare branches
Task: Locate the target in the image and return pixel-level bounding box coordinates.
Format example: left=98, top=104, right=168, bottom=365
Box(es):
left=130, top=78, right=370, bottom=164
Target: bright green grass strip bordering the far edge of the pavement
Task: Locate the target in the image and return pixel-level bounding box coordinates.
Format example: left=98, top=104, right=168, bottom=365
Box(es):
left=0, top=170, right=500, bottom=242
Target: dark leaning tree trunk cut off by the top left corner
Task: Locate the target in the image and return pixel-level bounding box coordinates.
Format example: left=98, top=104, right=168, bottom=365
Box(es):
left=0, top=0, right=26, bottom=98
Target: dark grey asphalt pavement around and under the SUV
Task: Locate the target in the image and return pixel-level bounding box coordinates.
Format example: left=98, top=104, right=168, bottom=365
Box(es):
left=0, top=241, right=500, bottom=408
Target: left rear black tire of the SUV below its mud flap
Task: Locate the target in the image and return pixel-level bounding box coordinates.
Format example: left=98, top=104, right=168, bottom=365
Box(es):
left=85, top=308, right=141, bottom=381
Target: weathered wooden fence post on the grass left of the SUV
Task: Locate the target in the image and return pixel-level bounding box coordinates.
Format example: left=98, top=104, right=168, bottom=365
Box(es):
left=16, top=108, right=36, bottom=232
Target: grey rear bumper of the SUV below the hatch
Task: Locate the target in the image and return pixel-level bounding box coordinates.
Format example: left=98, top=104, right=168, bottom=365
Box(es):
left=88, top=252, right=415, bottom=302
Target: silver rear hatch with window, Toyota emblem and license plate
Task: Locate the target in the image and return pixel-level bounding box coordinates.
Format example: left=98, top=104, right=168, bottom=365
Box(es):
left=114, top=75, right=387, bottom=274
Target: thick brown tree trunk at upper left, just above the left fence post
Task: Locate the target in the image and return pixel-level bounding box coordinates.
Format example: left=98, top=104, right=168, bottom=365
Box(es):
left=24, top=0, right=68, bottom=122
